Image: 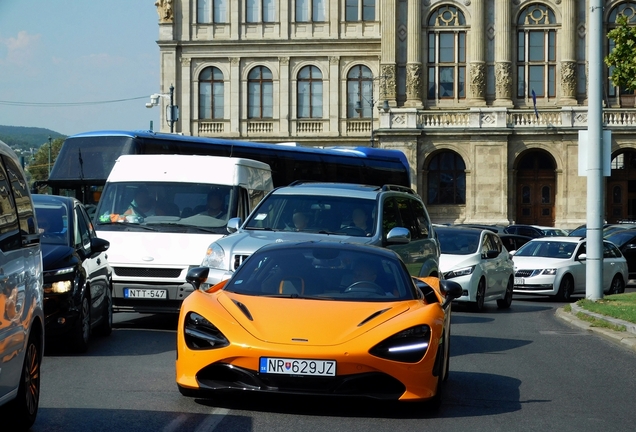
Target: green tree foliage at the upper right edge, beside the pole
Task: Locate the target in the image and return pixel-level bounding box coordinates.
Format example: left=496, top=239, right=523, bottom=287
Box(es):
left=605, top=14, right=636, bottom=90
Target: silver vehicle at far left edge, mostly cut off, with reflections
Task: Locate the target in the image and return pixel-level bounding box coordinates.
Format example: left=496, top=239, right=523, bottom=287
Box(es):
left=0, top=141, right=44, bottom=430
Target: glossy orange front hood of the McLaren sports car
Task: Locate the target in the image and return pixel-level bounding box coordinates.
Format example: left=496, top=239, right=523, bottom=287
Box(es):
left=218, top=292, right=412, bottom=346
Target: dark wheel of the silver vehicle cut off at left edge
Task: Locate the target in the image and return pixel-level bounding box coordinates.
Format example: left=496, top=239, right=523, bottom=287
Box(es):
left=0, top=334, right=42, bottom=430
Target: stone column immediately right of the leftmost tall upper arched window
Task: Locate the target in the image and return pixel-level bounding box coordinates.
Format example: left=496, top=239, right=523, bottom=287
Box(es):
left=468, top=0, right=486, bottom=106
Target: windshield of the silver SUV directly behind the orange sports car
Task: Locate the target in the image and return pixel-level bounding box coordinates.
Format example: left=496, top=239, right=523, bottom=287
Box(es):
left=244, top=194, right=376, bottom=237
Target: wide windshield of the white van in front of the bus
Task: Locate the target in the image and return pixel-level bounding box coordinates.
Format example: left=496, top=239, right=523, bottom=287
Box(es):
left=95, top=182, right=236, bottom=234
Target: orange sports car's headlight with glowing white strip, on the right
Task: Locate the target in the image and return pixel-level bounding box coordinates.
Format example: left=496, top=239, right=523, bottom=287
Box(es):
left=369, top=325, right=431, bottom=363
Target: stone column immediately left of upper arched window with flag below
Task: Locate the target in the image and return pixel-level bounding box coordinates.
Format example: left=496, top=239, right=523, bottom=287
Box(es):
left=493, top=0, right=513, bottom=107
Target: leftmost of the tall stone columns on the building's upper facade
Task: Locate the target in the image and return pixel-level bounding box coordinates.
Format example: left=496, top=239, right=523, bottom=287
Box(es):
left=380, top=0, right=397, bottom=106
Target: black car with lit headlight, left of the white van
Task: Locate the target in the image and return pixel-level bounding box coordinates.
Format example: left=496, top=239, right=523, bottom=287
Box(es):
left=33, top=195, right=113, bottom=352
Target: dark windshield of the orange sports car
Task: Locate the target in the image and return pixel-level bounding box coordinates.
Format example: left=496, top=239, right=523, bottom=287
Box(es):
left=224, top=243, right=416, bottom=301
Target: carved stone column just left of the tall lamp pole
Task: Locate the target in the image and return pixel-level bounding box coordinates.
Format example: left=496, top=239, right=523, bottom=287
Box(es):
left=557, top=0, right=577, bottom=105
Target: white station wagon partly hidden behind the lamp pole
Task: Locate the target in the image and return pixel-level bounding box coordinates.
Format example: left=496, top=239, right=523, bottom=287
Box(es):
left=512, top=237, right=629, bottom=301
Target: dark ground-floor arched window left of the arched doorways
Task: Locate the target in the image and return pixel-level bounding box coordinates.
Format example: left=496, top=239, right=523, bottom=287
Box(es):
left=428, top=150, right=466, bottom=204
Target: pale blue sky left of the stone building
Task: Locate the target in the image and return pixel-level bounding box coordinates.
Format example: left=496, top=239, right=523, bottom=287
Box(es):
left=0, top=0, right=160, bottom=135
